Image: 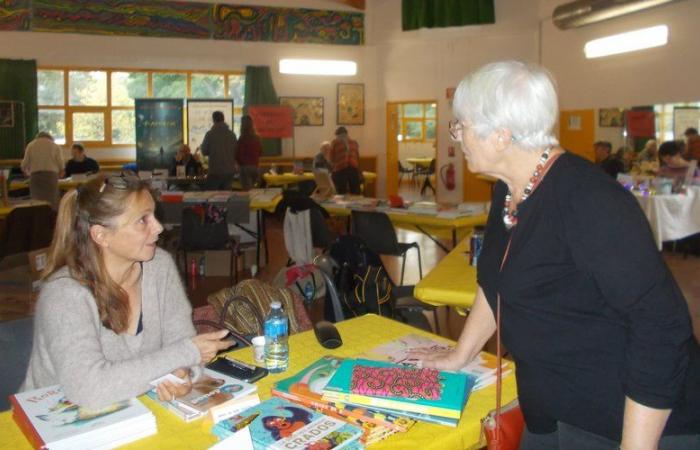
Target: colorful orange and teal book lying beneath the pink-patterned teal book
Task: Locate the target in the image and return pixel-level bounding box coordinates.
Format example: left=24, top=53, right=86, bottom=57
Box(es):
left=272, top=356, right=415, bottom=432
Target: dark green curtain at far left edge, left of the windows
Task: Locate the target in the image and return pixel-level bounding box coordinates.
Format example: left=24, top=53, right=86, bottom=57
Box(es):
left=0, top=59, right=39, bottom=159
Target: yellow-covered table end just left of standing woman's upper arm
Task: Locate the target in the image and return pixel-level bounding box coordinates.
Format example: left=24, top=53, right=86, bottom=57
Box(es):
left=413, top=239, right=478, bottom=308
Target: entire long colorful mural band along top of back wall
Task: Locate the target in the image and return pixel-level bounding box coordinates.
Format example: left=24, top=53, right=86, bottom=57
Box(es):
left=0, top=0, right=364, bottom=45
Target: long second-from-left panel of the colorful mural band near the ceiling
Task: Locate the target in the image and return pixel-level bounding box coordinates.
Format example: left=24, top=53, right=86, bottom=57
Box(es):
left=31, top=0, right=211, bottom=39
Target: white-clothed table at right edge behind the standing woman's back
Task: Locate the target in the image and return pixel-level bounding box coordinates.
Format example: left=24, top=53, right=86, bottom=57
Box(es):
left=634, top=186, right=700, bottom=250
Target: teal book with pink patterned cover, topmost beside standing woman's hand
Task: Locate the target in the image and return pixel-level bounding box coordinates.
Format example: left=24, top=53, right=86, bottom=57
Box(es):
left=323, top=359, right=475, bottom=419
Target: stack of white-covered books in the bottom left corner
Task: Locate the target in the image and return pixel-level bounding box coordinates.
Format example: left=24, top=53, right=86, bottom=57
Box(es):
left=10, top=386, right=157, bottom=450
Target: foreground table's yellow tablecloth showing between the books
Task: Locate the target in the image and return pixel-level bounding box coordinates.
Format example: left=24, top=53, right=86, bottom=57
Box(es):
left=0, top=314, right=517, bottom=450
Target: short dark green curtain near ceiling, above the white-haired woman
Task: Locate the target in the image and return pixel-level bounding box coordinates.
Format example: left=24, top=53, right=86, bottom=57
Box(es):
left=401, top=0, right=496, bottom=31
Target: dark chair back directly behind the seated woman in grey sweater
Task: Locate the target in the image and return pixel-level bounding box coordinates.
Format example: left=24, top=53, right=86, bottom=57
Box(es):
left=0, top=317, right=34, bottom=411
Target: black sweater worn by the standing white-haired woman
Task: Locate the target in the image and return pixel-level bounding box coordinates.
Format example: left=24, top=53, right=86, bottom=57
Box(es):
left=477, top=153, right=700, bottom=440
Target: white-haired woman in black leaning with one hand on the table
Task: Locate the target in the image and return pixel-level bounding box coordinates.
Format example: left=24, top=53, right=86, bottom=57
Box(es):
left=414, top=61, right=700, bottom=450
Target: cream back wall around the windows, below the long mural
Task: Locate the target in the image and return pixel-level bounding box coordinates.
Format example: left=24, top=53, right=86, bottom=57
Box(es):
left=0, top=0, right=366, bottom=159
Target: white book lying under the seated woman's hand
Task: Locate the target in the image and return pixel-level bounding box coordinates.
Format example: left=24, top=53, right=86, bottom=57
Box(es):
left=148, top=368, right=258, bottom=422
